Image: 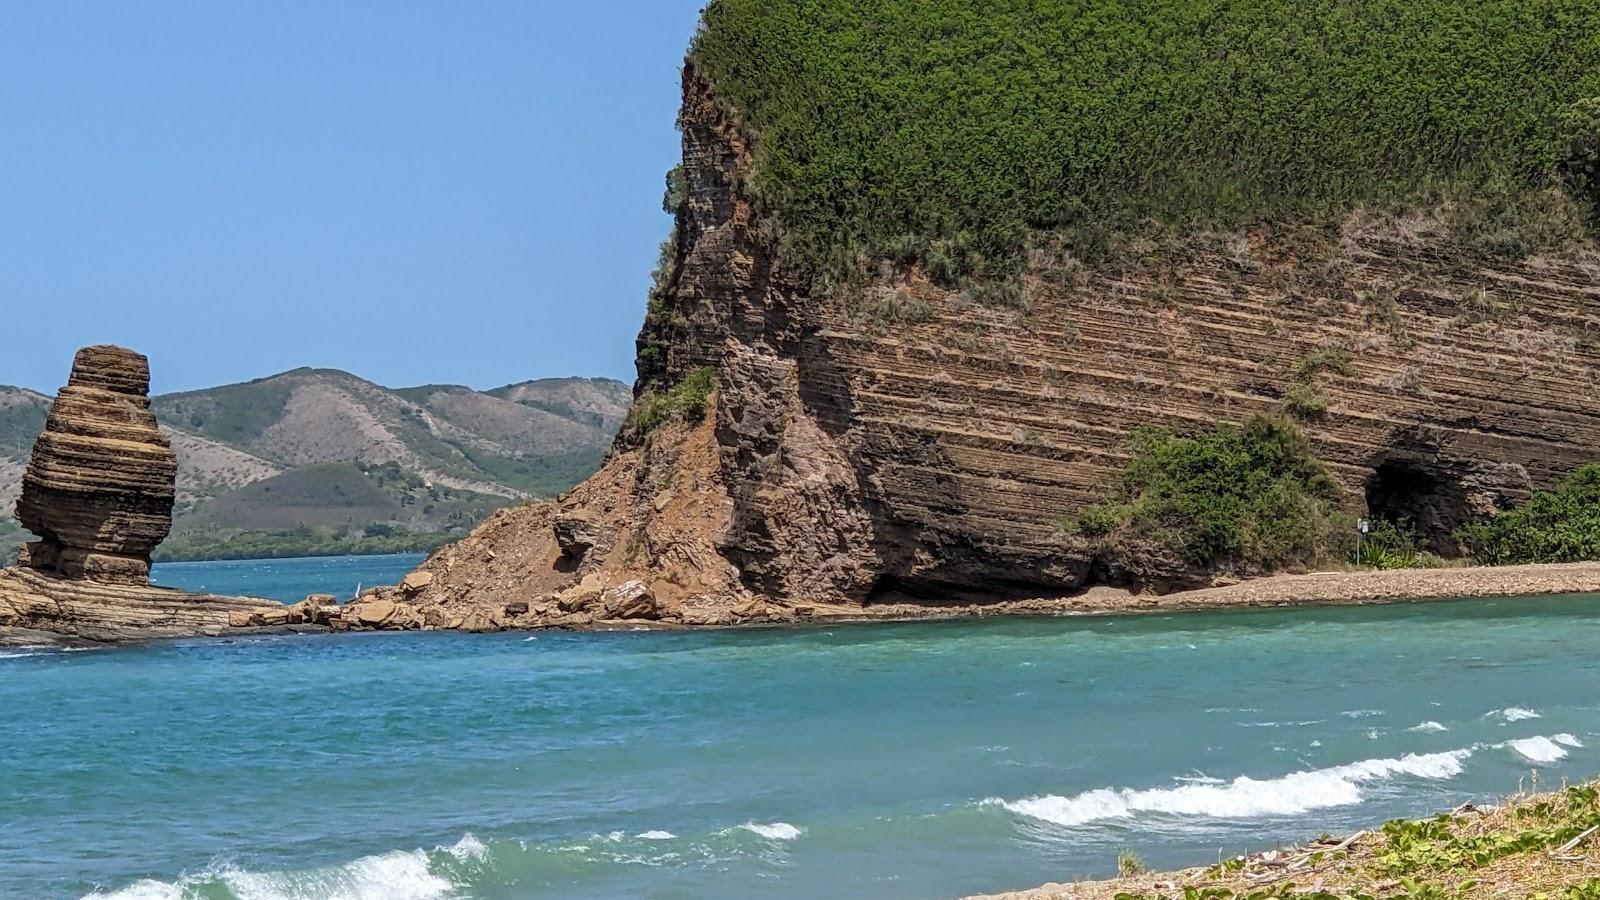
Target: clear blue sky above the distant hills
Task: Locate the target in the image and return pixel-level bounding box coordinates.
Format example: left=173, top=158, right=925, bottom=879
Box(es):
left=0, top=0, right=704, bottom=391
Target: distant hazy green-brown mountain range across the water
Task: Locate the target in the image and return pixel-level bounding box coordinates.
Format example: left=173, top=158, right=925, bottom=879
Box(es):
left=0, top=368, right=632, bottom=559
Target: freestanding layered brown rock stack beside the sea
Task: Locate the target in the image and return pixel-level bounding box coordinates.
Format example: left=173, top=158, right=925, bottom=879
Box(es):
left=16, top=344, right=178, bottom=585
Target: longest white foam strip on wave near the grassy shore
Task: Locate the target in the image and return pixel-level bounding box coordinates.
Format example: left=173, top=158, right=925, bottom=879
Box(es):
left=984, top=749, right=1472, bottom=828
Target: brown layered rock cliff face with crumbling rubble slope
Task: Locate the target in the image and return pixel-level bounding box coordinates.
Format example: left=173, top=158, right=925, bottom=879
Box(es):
left=396, top=67, right=1600, bottom=621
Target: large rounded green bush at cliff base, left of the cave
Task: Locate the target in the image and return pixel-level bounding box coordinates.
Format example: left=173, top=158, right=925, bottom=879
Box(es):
left=1075, top=416, right=1347, bottom=570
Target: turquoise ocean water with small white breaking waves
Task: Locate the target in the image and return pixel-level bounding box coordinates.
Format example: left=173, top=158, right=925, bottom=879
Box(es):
left=0, top=550, right=1600, bottom=900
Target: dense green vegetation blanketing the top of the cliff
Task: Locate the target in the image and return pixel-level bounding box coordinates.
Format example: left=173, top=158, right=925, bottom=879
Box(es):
left=691, top=0, right=1600, bottom=282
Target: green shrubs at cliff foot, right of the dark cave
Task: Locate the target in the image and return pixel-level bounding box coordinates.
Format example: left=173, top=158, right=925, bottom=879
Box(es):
left=1456, top=463, right=1600, bottom=565
